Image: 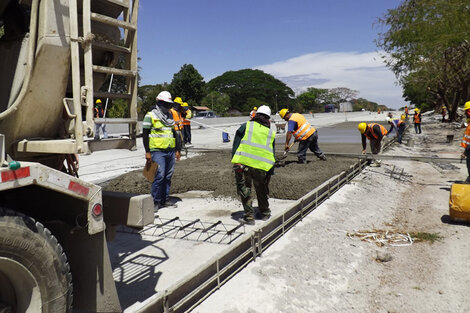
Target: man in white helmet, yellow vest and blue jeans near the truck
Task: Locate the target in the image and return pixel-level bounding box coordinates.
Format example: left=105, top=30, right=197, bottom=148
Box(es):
left=142, top=91, right=182, bottom=210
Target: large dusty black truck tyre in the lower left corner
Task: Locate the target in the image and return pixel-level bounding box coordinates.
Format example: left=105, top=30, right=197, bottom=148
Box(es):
left=0, top=207, right=72, bottom=313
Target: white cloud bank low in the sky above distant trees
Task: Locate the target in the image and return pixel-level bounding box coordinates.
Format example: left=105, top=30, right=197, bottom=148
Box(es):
left=256, top=52, right=406, bottom=108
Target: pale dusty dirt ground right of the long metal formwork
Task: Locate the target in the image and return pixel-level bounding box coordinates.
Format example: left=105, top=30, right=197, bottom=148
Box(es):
left=194, top=115, right=470, bottom=313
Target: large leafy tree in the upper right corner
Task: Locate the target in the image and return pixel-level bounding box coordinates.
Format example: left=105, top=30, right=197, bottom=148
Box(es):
left=377, top=0, right=470, bottom=120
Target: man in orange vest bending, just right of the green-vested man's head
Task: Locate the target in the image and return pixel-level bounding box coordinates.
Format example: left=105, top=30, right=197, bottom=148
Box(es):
left=279, top=109, right=326, bottom=164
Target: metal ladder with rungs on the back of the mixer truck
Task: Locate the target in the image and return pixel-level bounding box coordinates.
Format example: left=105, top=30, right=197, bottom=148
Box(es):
left=82, top=0, right=139, bottom=150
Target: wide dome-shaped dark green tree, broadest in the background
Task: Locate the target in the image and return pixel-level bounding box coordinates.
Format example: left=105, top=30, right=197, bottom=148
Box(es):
left=207, top=69, right=294, bottom=113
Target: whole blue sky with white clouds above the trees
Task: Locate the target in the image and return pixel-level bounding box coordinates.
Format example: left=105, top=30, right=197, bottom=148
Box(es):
left=138, top=0, right=407, bottom=109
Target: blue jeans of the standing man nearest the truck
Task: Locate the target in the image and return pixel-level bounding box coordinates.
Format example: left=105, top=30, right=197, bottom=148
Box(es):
left=152, top=150, right=176, bottom=204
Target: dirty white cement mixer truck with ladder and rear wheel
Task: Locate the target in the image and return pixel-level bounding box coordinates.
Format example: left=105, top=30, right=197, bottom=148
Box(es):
left=0, top=0, right=153, bottom=312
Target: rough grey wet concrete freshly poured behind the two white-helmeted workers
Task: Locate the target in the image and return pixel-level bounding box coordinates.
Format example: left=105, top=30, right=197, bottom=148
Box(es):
left=103, top=146, right=355, bottom=200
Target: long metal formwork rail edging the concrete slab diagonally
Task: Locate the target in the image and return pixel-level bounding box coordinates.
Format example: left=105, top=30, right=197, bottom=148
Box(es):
left=134, top=160, right=369, bottom=313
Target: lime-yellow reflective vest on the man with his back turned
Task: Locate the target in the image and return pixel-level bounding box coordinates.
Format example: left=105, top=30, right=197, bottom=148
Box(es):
left=232, top=122, right=276, bottom=172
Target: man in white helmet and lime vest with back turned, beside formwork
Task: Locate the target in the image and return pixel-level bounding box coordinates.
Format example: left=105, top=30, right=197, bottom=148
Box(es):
left=232, top=105, right=276, bottom=225
